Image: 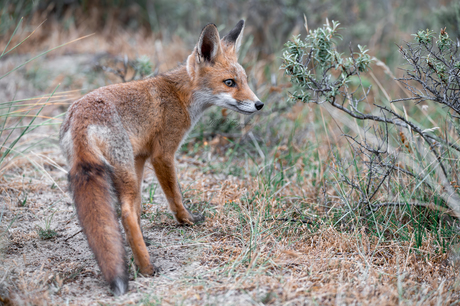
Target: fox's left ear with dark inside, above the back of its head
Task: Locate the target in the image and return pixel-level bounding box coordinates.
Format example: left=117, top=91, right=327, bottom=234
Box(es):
left=196, top=23, right=221, bottom=63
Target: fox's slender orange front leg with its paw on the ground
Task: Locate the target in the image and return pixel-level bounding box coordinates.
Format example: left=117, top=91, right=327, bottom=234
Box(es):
left=152, top=154, right=204, bottom=224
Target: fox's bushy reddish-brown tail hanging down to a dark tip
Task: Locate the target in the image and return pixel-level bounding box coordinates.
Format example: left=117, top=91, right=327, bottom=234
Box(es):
left=69, top=151, right=128, bottom=295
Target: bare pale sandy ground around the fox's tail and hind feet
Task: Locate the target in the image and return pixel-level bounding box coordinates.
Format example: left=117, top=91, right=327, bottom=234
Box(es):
left=0, top=148, right=210, bottom=305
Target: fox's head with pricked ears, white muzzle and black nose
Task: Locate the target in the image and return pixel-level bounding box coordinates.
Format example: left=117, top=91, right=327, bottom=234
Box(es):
left=187, top=20, right=264, bottom=115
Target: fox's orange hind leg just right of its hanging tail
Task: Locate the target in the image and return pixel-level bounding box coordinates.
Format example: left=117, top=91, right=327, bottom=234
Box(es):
left=114, top=167, right=156, bottom=275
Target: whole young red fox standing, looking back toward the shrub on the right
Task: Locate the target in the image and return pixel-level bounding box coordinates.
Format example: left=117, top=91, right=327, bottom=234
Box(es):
left=60, top=20, right=264, bottom=295
